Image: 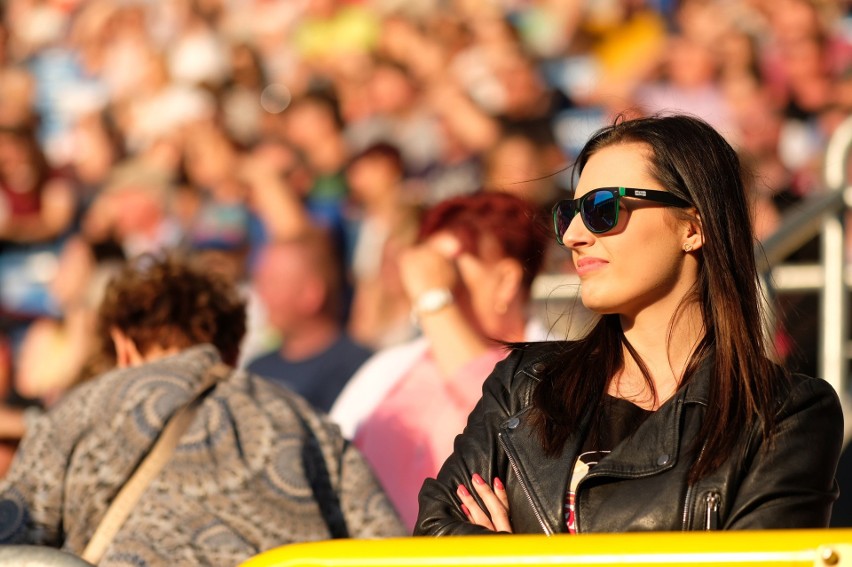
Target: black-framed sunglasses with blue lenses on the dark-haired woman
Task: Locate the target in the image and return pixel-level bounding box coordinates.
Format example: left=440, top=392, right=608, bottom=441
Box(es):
left=553, top=187, right=692, bottom=245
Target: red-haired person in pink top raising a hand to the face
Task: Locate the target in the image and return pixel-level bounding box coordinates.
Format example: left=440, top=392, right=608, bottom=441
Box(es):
left=331, top=191, right=547, bottom=529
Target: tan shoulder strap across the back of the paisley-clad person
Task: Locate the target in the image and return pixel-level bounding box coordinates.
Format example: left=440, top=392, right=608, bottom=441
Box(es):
left=81, top=363, right=230, bottom=564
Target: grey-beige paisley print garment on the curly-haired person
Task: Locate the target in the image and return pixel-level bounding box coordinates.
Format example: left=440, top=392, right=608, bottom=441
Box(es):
left=0, top=345, right=405, bottom=567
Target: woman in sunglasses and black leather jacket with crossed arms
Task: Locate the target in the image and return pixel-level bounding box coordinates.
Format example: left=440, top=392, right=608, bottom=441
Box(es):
left=415, top=115, right=843, bottom=535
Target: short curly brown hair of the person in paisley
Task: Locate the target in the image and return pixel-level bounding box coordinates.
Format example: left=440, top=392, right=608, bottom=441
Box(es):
left=97, top=252, right=246, bottom=365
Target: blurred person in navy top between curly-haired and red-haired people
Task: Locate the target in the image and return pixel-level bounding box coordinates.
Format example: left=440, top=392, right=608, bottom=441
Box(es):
left=241, top=231, right=371, bottom=411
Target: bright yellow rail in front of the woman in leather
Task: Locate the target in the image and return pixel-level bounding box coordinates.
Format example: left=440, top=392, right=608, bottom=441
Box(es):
left=242, top=529, right=852, bottom=567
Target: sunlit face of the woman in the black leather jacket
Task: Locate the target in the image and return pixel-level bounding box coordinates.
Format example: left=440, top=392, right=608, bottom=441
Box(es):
left=563, top=144, right=700, bottom=322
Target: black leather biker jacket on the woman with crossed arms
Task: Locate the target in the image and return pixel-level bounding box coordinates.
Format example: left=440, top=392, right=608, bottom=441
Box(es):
left=414, top=343, right=843, bottom=535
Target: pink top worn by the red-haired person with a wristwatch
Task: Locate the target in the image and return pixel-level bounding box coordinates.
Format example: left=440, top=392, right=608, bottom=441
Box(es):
left=354, top=348, right=507, bottom=531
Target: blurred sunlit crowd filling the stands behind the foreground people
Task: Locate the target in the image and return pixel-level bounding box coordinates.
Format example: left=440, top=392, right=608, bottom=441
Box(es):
left=0, top=0, right=852, bottom=480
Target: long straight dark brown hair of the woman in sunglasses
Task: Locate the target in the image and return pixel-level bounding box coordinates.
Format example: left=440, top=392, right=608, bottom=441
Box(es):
left=533, top=115, right=782, bottom=482
